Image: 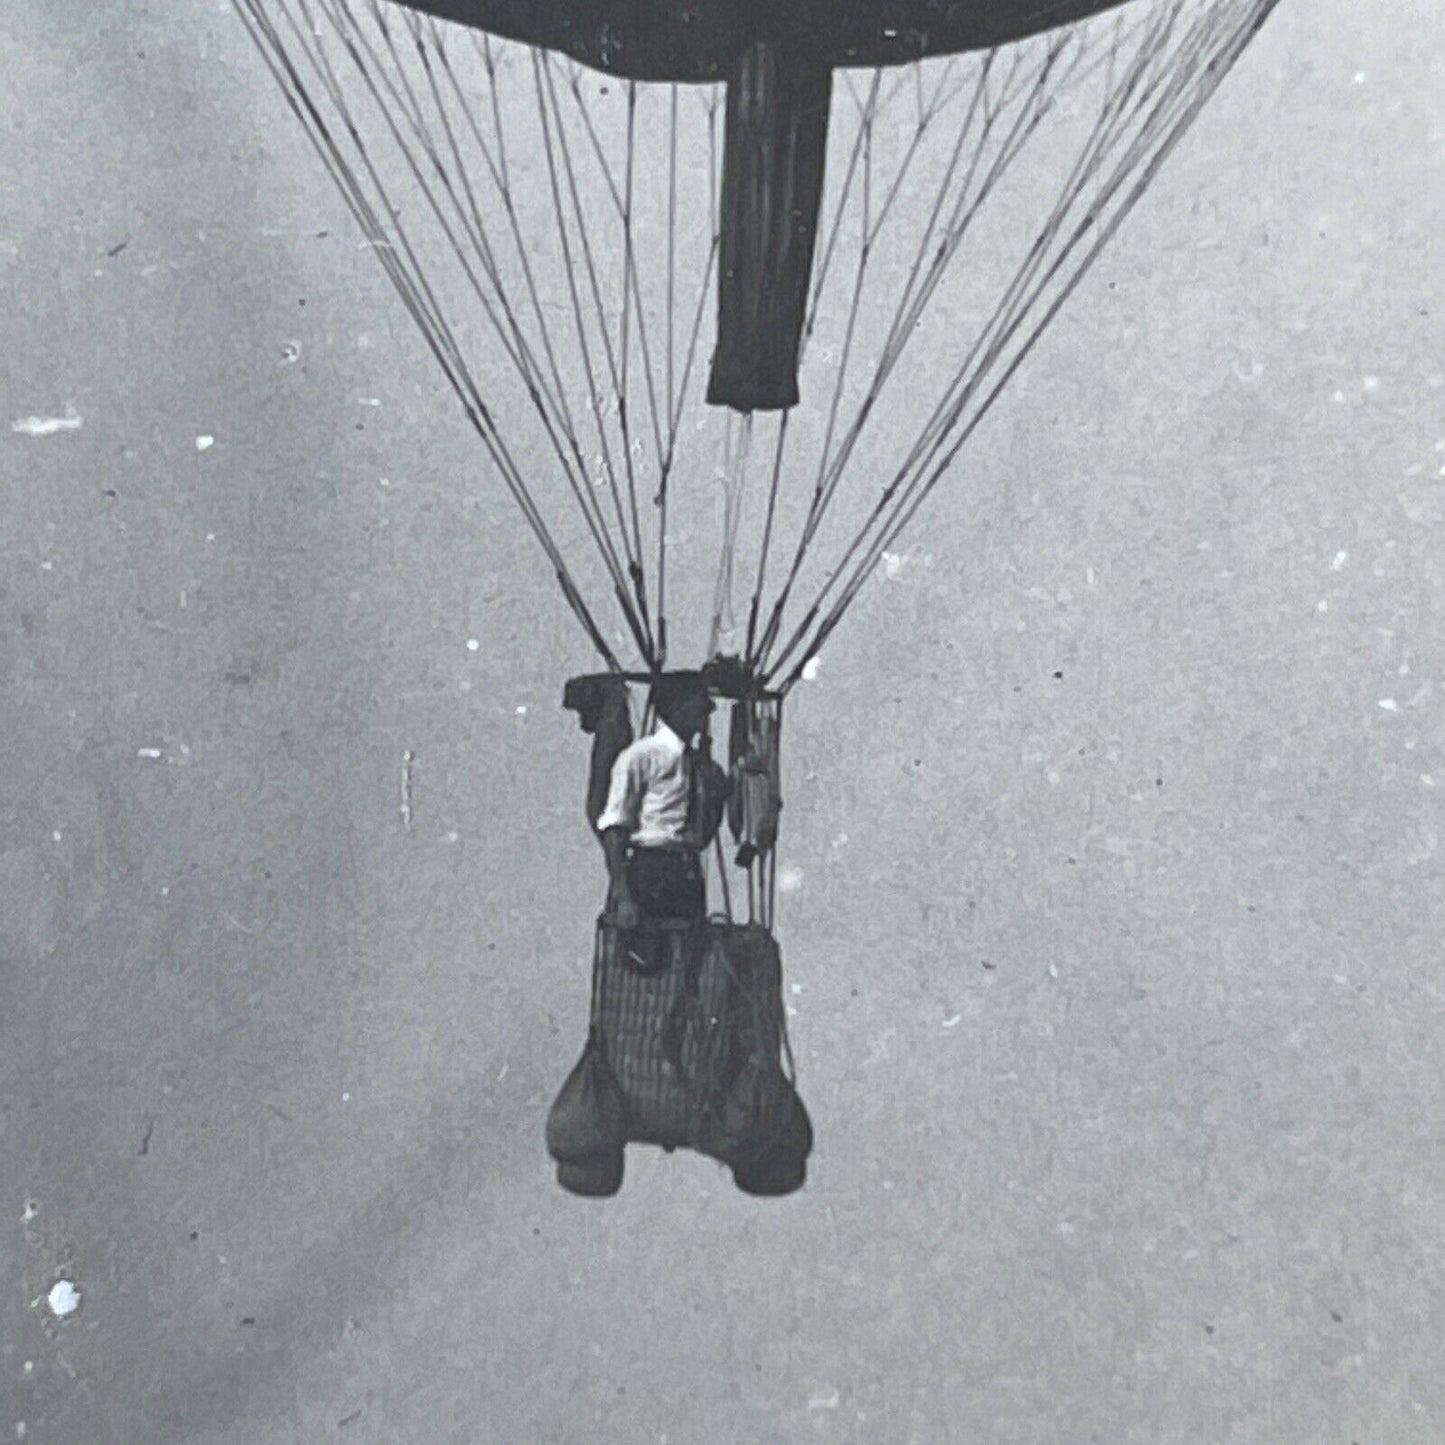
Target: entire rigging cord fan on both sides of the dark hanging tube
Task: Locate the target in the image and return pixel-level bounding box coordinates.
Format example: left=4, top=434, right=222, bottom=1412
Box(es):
left=233, top=0, right=1277, bottom=679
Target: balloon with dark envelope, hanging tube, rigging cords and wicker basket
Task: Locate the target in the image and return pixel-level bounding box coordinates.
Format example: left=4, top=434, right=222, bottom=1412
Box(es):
left=222, top=0, right=1277, bottom=1194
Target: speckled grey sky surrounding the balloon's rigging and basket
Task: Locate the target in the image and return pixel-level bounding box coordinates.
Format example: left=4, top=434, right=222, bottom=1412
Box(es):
left=0, top=0, right=1445, bottom=1445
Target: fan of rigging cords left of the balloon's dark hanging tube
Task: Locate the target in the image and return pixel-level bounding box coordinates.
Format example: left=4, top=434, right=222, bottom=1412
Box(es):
left=233, top=0, right=718, bottom=669
